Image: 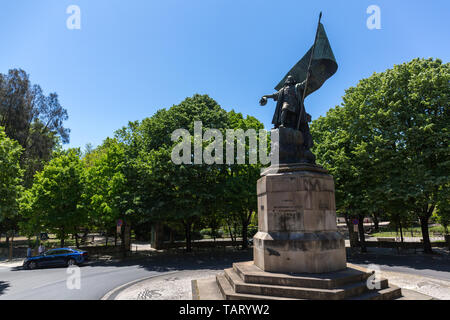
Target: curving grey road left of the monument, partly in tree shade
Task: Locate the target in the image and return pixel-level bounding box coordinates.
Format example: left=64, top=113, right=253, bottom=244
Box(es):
left=0, top=251, right=251, bottom=300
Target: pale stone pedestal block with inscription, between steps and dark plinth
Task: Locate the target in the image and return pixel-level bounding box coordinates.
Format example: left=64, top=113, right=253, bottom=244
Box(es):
left=254, top=165, right=346, bottom=273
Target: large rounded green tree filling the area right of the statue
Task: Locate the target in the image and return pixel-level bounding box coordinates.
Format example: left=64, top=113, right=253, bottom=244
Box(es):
left=312, top=59, right=450, bottom=253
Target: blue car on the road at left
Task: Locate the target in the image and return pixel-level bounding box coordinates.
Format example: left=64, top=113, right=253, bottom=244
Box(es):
left=23, top=248, right=88, bottom=270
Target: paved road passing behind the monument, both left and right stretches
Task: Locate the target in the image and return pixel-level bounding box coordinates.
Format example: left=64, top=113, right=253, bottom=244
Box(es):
left=0, top=250, right=450, bottom=300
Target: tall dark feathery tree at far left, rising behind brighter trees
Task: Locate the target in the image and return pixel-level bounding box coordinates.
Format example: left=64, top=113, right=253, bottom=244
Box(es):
left=0, top=69, right=70, bottom=187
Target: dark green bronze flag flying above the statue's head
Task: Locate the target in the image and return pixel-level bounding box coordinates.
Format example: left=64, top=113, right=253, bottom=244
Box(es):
left=275, top=23, right=338, bottom=96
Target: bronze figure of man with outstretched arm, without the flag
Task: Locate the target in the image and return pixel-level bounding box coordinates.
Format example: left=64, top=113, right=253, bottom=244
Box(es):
left=259, top=76, right=313, bottom=150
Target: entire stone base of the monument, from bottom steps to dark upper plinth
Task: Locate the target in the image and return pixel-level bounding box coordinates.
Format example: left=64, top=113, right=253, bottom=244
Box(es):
left=192, top=129, right=408, bottom=300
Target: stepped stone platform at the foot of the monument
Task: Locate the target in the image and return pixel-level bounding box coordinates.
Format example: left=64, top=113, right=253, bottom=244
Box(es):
left=192, top=262, right=402, bottom=300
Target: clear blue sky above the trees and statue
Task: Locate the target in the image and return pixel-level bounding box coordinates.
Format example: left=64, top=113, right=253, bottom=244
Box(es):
left=0, top=0, right=450, bottom=148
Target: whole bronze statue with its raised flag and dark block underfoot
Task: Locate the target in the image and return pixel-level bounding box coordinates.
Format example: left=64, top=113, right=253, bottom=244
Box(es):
left=260, top=13, right=338, bottom=164
